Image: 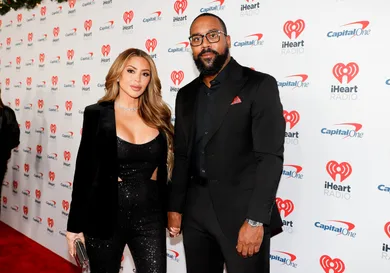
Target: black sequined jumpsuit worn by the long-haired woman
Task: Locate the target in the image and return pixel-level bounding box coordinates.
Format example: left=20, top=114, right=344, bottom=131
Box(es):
left=85, top=134, right=167, bottom=273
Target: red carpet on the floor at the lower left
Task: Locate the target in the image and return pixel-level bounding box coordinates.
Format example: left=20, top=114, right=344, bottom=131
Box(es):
left=0, top=221, right=81, bottom=273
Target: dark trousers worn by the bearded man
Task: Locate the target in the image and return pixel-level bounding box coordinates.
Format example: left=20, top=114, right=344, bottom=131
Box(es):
left=183, top=182, right=270, bottom=273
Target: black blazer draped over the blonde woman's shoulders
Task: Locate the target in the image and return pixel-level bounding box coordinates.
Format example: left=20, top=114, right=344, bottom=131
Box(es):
left=67, top=102, right=168, bottom=238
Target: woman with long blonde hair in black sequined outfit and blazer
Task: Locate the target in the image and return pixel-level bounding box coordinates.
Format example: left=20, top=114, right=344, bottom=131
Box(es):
left=67, top=48, right=173, bottom=273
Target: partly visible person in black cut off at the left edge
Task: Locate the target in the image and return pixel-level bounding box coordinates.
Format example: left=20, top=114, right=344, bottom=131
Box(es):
left=0, top=89, right=20, bottom=201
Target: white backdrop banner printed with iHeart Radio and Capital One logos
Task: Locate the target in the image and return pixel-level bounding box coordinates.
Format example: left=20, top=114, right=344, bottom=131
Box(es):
left=0, top=0, right=390, bottom=273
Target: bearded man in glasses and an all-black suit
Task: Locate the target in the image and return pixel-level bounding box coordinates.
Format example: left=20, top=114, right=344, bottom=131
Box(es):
left=168, top=13, right=285, bottom=273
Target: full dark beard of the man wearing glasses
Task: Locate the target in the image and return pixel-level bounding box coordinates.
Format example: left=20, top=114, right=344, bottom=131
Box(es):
left=193, top=47, right=229, bottom=76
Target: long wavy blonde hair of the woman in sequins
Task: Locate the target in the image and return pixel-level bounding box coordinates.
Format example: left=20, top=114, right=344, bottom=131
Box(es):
left=99, top=48, right=173, bottom=180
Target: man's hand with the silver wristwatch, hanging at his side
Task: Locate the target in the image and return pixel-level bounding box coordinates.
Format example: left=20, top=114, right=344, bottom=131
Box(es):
left=236, top=221, right=264, bottom=258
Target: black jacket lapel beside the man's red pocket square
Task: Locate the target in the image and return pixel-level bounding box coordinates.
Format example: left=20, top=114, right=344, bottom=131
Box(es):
left=205, top=60, right=247, bottom=145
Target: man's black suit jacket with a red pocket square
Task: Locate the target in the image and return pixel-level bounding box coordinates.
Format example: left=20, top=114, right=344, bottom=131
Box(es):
left=168, top=59, right=285, bottom=240
